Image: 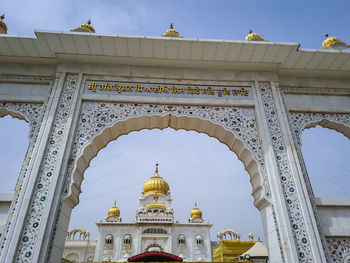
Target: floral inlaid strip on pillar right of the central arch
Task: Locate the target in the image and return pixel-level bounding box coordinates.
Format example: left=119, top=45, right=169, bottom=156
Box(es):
left=260, top=83, right=313, bottom=262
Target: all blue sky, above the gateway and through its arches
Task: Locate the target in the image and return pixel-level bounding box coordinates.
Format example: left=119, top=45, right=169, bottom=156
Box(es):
left=0, top=0, right=350, bottom=244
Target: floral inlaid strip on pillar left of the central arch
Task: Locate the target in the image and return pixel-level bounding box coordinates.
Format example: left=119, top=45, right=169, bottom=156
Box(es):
left=16, top=76, right=77, bottom=262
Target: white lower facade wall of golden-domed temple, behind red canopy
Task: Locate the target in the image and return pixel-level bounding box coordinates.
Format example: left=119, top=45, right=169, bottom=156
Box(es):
left=95, top=223, right=212, bottom=261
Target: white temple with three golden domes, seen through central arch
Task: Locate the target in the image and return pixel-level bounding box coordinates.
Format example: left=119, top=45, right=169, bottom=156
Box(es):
left=63, top=164, right=212, bottom=262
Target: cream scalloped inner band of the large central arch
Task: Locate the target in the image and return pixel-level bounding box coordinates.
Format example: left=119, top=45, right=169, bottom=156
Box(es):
left=66, top=114, right=267, bottom=209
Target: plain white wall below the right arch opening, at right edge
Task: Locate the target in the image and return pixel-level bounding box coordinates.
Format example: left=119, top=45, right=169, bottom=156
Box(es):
left=315, top=197, right=350, bottom=237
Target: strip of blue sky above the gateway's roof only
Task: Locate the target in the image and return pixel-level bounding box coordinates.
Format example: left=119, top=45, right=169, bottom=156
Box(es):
left=0, top=0, right=350, bottom=49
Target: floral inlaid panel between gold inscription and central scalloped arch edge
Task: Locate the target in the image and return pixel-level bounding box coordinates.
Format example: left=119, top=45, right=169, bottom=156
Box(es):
left=64, top=102, right=271, bottom=198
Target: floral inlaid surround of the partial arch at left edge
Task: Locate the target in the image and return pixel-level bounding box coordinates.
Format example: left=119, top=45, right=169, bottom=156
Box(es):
left=0, top=102, right=45, bottom=254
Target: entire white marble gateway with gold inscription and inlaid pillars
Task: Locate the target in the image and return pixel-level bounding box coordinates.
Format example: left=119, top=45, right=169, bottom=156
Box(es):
left=0, top=25, right=350, bottom=262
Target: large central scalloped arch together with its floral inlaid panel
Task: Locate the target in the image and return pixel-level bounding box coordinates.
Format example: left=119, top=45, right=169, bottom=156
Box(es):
left=64, top=102, right=271, bottom=206
